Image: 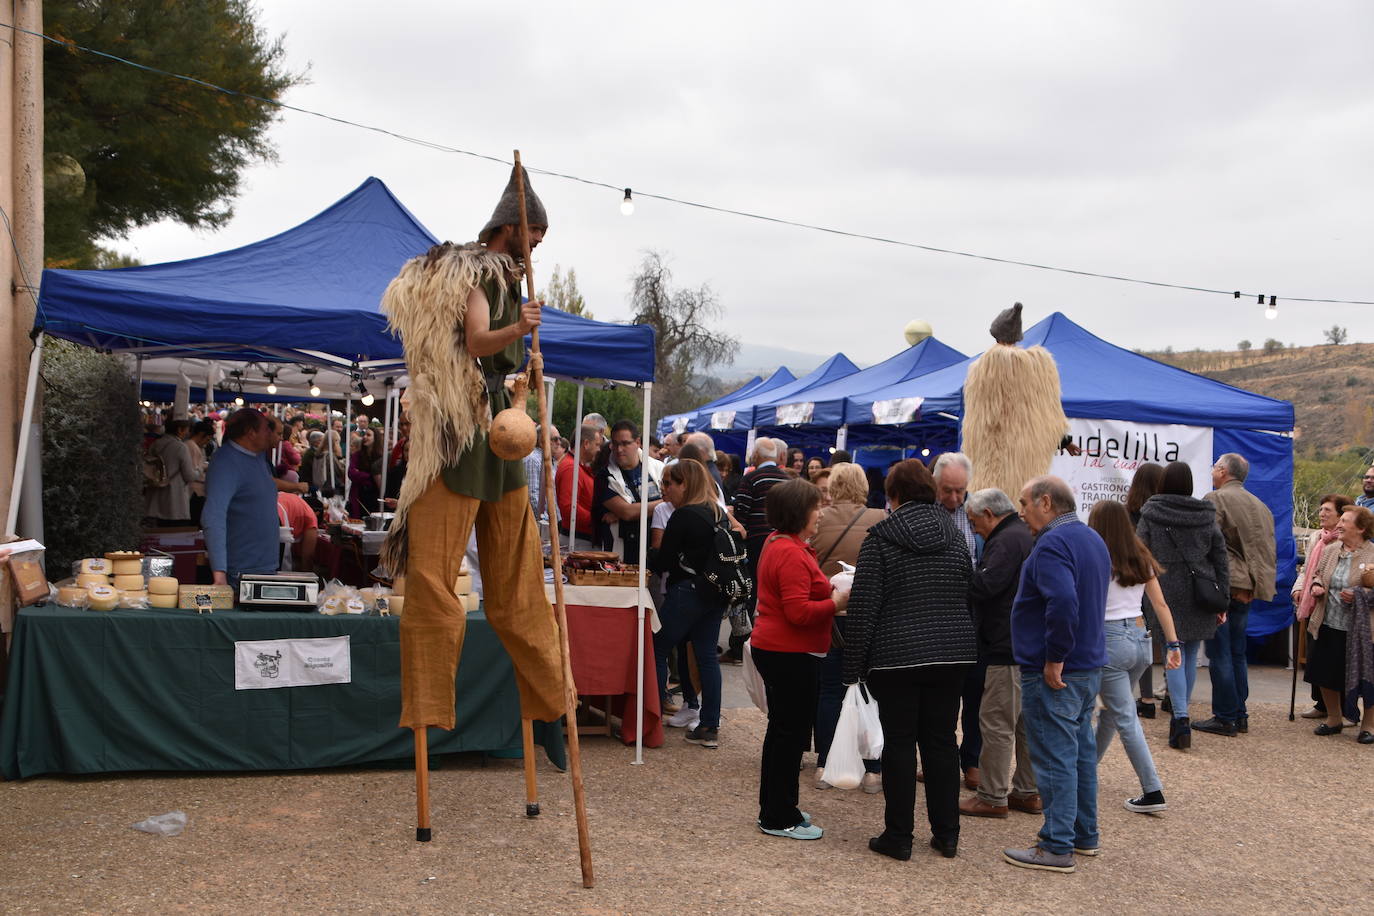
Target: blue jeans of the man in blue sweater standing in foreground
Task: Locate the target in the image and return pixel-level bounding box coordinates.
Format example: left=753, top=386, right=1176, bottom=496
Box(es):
left=1021, top=667, right=1102, bottom=856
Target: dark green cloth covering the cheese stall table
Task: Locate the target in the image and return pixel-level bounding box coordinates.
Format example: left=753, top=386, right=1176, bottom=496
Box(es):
left=0, top=606, right=565, bottom=779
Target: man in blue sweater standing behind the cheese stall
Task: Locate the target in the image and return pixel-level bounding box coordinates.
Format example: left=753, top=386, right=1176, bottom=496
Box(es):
left=201, top=407, right=282, bottom=586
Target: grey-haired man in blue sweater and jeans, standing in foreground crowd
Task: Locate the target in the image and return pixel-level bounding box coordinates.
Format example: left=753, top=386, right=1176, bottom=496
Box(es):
left=1003, top=477, right=1112, bottom=872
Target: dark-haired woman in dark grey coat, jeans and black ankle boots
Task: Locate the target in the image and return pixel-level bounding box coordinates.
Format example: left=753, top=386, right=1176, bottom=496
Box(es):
left=1135, top=461, right=1231, bottom=750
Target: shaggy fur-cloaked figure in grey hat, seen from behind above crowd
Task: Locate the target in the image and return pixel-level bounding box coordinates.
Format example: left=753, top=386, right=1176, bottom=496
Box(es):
left=963, top=302, right=1069, bottom=501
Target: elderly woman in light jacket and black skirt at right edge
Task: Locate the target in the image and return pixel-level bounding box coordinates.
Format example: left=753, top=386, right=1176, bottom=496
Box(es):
left=1304, top=505, right=1374, bottom=744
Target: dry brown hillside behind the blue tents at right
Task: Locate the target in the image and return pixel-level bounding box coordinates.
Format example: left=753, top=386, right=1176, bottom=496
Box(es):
left=1145, top=343, right=1374, bottom=455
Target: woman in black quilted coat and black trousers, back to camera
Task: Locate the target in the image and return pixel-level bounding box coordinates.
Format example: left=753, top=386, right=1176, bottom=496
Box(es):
left=844, top=459, right=977, bottom=860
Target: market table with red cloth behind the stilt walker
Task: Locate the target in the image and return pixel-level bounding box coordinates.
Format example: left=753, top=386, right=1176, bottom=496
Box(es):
left=544, top=584, right=664, bottom=747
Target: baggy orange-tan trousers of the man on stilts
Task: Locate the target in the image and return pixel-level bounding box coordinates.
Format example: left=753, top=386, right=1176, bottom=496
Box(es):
left=400, top=479, right=567, bottom=729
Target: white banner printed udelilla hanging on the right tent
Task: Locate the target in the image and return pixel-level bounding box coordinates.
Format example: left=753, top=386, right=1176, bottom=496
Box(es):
left=1044, top=417, right=1212, bottom=522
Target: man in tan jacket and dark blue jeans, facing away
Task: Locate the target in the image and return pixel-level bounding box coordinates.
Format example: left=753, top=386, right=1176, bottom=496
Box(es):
left=1193, top=452, right=1276, bottom=737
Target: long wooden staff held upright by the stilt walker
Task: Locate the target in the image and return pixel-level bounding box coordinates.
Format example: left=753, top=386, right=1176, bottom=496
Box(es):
left=515, top=150, right=596, bottom=887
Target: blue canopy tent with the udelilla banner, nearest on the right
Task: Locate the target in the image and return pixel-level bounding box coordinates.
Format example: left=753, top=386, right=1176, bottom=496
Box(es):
left=846, top=312, right=1297, bottom=637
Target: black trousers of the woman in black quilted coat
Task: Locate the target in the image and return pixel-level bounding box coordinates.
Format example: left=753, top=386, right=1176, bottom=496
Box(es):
left=868, top=665, right=971, bottom=846
